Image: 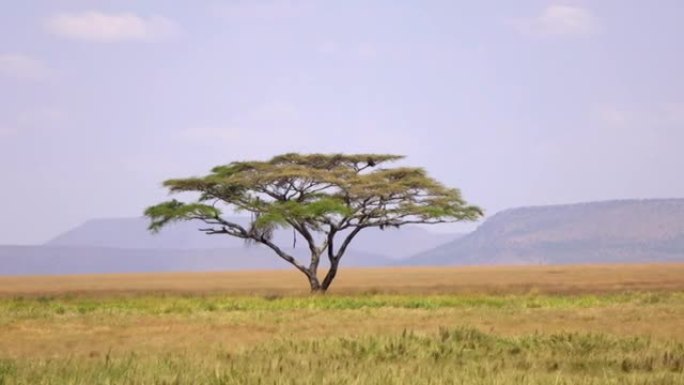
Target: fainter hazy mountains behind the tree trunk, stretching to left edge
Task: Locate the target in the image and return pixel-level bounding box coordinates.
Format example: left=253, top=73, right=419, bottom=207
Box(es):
left=0, top=218, right=461, bottom=275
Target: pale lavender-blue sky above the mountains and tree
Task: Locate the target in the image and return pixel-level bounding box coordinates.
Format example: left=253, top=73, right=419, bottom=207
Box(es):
left=0, top=0, right=684, bottom=244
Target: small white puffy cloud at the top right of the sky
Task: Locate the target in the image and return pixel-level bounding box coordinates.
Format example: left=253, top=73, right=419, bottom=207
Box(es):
left=511, top=4, right=599, bottom=36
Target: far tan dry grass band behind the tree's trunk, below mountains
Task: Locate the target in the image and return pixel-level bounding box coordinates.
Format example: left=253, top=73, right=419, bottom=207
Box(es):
left=0, top=263, right=684, bottom=297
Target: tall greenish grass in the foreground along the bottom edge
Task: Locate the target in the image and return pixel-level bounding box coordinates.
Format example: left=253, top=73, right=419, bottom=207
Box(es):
left=0, top=328, right=684, bottom=385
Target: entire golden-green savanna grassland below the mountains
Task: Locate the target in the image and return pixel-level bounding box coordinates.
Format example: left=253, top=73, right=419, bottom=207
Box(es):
left=0, top=264, right=684, bottom=385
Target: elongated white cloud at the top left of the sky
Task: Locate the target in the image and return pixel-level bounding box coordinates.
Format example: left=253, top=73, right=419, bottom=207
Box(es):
left=45, top=11, right=180, bottom=43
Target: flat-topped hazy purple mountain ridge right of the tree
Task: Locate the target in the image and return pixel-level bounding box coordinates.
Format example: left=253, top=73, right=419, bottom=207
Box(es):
left=402, top=199, right=684, bottom=265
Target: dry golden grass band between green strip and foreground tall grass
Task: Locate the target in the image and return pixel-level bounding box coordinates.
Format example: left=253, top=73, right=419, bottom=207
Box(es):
left=5, top=300, right=684, bottom=358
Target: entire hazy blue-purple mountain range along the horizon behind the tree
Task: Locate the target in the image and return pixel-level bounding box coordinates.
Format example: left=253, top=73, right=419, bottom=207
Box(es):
left=0, top=199, right=684, bottom=275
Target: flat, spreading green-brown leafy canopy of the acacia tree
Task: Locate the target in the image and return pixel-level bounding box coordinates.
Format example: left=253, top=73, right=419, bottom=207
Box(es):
left=145, top=153, right=482, bottom=230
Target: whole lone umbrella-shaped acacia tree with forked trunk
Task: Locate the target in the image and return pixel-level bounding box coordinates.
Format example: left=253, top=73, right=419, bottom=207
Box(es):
left=145, top=153, right=482, bottom=292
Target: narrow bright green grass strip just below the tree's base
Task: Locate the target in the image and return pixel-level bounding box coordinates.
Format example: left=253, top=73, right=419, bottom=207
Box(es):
left=0, top=292, right=684, bottom=322
